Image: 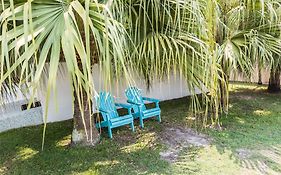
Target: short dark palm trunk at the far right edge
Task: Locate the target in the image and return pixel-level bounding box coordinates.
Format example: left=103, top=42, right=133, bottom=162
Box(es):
left=267, top=68, right=280, bottom=93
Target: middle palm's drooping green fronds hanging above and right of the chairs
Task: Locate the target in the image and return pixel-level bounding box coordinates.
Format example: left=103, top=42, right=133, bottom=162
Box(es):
left=112, top=0, right=223, bottom=126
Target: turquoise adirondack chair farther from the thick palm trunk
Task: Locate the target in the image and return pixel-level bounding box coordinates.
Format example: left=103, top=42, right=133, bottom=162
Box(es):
left=125, top=87, right=161, bottom=128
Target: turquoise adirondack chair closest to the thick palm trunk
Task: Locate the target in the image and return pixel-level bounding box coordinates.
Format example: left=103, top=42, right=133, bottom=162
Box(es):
left=95, top=92, right=135, bottom=138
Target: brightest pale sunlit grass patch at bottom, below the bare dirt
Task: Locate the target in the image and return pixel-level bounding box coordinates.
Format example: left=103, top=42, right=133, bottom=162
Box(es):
left=173, top=146, right=259, bottom=175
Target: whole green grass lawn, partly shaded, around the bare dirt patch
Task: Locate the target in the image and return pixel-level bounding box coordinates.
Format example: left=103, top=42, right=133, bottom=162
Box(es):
left=0, top=84, right=281, bottom=175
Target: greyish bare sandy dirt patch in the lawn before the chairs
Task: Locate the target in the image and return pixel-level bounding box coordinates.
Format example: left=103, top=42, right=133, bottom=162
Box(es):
left=160, top=127, right=210, bottom=163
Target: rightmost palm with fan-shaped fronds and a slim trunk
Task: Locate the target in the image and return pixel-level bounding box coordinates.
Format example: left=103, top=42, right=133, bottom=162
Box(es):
left=206, top=0, right=280, bottom=111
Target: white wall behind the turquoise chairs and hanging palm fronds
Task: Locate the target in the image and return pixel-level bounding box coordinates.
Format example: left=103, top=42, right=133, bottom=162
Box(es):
left=0, top=64, right=195, bottom=132
